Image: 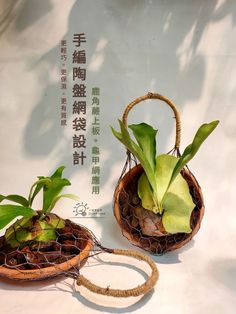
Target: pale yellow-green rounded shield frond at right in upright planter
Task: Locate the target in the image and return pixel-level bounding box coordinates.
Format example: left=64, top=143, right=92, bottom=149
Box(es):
left=162, top=174, right=195, bottom=234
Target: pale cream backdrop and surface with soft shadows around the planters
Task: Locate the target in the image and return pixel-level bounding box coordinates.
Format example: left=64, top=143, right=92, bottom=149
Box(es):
left=0, top=0, right=236, bottom=314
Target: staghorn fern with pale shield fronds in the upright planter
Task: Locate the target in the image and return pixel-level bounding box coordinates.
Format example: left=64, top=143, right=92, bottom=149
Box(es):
left=112, top=120, right=219, bottom=234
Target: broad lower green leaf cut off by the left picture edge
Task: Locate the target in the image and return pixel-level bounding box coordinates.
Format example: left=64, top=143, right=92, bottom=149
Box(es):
left=0, top=205, right=36, bottom=229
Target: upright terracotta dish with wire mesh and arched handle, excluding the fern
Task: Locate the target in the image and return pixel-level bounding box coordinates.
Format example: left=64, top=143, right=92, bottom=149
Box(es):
left=114, top=93, right=204, bottom=255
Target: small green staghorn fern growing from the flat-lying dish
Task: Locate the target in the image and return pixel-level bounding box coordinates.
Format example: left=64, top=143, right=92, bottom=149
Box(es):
left=0, top=166, right=78, bottom=247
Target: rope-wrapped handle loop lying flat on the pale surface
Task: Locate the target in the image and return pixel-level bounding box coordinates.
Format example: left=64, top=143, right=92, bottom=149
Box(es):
left=77, top=249, right=159, bottom=298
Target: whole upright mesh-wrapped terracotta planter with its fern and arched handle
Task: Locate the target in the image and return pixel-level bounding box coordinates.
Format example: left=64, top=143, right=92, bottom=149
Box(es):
left=112, top=93, right=219, bottom=254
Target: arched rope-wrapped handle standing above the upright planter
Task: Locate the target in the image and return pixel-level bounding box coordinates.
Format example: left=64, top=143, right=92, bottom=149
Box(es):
left=122, top=93, right=181, bottom=150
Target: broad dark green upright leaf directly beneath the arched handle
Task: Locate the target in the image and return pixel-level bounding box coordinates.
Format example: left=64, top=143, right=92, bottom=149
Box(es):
left=129, top=123, right=157, bottom=170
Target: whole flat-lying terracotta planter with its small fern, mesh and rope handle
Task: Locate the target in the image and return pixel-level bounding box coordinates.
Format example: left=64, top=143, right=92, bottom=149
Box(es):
left=0, top=166, right=159, bottom=297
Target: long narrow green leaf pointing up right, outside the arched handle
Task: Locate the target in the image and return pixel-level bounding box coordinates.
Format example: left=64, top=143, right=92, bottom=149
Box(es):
left=170, top=120, right=219, bottom=184
